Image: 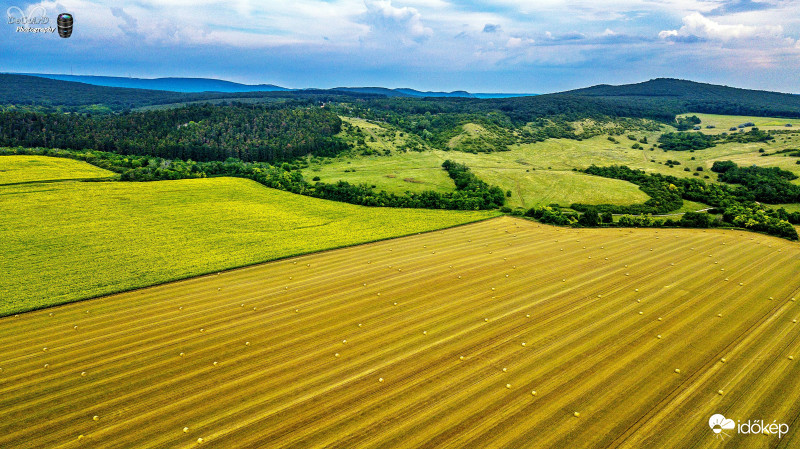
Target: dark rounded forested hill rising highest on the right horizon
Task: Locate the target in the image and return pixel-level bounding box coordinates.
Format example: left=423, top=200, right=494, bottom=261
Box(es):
left=556, top=78, right=800, bottom=117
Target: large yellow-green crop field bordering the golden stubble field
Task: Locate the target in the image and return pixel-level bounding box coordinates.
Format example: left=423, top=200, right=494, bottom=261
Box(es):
left=0, top=173, right=492, bottom=315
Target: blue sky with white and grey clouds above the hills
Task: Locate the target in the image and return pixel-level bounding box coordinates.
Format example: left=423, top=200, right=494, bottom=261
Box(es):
left=0, top=0, right=800, bottom=93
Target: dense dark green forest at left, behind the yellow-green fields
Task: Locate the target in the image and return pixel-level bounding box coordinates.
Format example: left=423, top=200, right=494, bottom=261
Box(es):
left=0, top=103, right=345, bottom=162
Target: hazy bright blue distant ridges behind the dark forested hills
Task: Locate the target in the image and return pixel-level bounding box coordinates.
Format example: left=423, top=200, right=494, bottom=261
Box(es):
left=12, top=73, right=535, bottom=98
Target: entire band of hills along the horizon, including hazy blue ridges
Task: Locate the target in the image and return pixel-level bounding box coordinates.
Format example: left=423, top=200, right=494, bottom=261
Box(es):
left=0, top=74, right=800, bottom=122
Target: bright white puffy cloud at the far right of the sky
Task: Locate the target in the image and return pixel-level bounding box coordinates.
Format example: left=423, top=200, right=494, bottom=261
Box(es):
left=658, top=12, right=783, bottom=41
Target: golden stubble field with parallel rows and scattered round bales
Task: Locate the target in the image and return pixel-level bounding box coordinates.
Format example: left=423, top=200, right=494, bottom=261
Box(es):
left=0, top=217, right=800, bottom=448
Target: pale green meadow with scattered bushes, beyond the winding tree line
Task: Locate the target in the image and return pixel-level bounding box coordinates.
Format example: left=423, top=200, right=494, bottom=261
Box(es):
left=310, top=114, right=800, bottom=208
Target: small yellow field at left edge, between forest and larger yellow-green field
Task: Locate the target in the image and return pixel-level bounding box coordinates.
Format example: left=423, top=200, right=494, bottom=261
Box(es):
left=0, top=156, right=116, bottom=184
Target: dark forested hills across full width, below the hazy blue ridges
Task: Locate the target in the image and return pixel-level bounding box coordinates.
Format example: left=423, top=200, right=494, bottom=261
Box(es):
left=0, top=74, right=800, bottom=121
